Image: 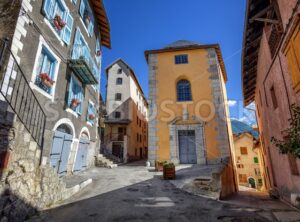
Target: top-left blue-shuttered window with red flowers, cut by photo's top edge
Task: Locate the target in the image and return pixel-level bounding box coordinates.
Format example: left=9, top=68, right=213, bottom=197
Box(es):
left=42, top=0, right=74, bottom=45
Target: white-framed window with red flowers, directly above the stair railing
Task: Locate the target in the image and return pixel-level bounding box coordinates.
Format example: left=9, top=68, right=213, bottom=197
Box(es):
left=30, top=36, right=61, bottom=100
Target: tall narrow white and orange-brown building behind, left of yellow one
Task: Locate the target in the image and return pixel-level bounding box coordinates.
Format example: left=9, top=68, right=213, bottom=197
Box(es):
left=104, top=59, right=148, bottom=162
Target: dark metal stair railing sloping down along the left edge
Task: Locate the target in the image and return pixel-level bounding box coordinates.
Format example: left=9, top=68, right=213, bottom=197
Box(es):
left=0, top=40, right=46, bottom=149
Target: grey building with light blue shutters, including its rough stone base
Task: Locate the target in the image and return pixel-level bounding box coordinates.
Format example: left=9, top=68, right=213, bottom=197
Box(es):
left=0, top=0, right=110, bottom=221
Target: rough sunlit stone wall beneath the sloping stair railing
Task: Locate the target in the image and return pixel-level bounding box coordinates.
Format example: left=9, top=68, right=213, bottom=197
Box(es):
left=0, top=109, right=68, bottom=221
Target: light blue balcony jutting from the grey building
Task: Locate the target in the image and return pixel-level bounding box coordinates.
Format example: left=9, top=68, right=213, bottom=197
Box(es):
left=70, top=46, right=99, bottom=85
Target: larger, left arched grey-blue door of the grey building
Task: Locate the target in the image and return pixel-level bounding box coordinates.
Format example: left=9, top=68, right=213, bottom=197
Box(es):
left=50, top=123, right=73, bottom=176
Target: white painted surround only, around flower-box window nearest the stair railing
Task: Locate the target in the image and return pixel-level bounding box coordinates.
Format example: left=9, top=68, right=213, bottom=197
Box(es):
left=29, top=36, right=61, bottom=101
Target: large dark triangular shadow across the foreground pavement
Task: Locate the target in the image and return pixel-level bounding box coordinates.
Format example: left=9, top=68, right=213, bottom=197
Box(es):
left=30, top=176, right=274, bottom=222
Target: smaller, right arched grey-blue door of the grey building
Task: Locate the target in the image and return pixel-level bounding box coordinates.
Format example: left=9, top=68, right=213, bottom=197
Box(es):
left=73, top=132, right=90, bottom=173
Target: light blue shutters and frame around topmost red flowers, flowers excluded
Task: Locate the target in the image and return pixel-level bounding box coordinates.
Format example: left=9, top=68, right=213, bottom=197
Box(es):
left=42, top=0, right=74, bottom=45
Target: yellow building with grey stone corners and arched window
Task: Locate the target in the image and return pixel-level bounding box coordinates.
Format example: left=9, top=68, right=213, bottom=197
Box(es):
left=145, top=41, right=232, bottom=165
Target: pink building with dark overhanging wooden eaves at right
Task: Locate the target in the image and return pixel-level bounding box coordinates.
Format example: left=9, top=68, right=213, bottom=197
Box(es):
left=242, top=0, right=300, bottom=204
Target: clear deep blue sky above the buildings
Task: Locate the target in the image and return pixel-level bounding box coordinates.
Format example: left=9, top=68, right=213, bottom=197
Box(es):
left=101, top=0, right=255, bottom=124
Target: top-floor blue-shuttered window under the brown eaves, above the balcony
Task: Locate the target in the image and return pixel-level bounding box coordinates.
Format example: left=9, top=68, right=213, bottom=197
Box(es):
left=79, top=0, right=95, bottom=37
